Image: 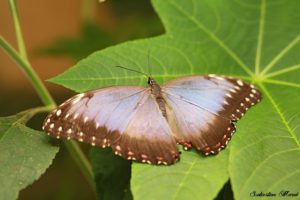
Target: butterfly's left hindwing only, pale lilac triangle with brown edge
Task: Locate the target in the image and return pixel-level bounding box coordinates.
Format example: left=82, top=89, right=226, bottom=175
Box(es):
left=112, top=93, right=179, bottom=165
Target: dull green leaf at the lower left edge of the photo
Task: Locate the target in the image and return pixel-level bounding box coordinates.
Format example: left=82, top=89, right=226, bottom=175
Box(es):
left=0, top=111, right=58, bottom=200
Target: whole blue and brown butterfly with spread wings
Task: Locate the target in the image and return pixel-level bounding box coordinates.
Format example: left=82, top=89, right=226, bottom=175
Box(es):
left=43, top=74, right=262, bottom=165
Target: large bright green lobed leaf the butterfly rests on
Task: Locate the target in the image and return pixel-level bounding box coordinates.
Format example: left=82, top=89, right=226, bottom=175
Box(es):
left=52, top=0, right=300, bottom=199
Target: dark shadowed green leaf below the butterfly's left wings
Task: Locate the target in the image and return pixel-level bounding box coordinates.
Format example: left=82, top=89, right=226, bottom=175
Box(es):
left=90, top=148, right=132, bottom=200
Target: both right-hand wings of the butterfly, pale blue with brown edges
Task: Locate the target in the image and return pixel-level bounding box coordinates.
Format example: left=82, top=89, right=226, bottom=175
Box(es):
left=162, top=75, right=261, bottom=155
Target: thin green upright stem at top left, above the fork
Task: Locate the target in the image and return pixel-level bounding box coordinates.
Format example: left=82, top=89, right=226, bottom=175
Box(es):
left=9, top=0, right=28, bottom=61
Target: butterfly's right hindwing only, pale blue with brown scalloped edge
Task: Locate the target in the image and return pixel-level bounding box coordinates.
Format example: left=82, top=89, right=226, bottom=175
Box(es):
left=166, top=91, right=235, bottom=155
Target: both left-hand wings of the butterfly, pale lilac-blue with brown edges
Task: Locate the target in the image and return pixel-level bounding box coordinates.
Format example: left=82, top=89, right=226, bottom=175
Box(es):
left=43, top=86, right=178, bottom=164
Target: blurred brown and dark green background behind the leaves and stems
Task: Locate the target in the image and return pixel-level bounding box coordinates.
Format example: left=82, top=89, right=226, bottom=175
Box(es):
left=0, top=0, right=164, bottom=200
